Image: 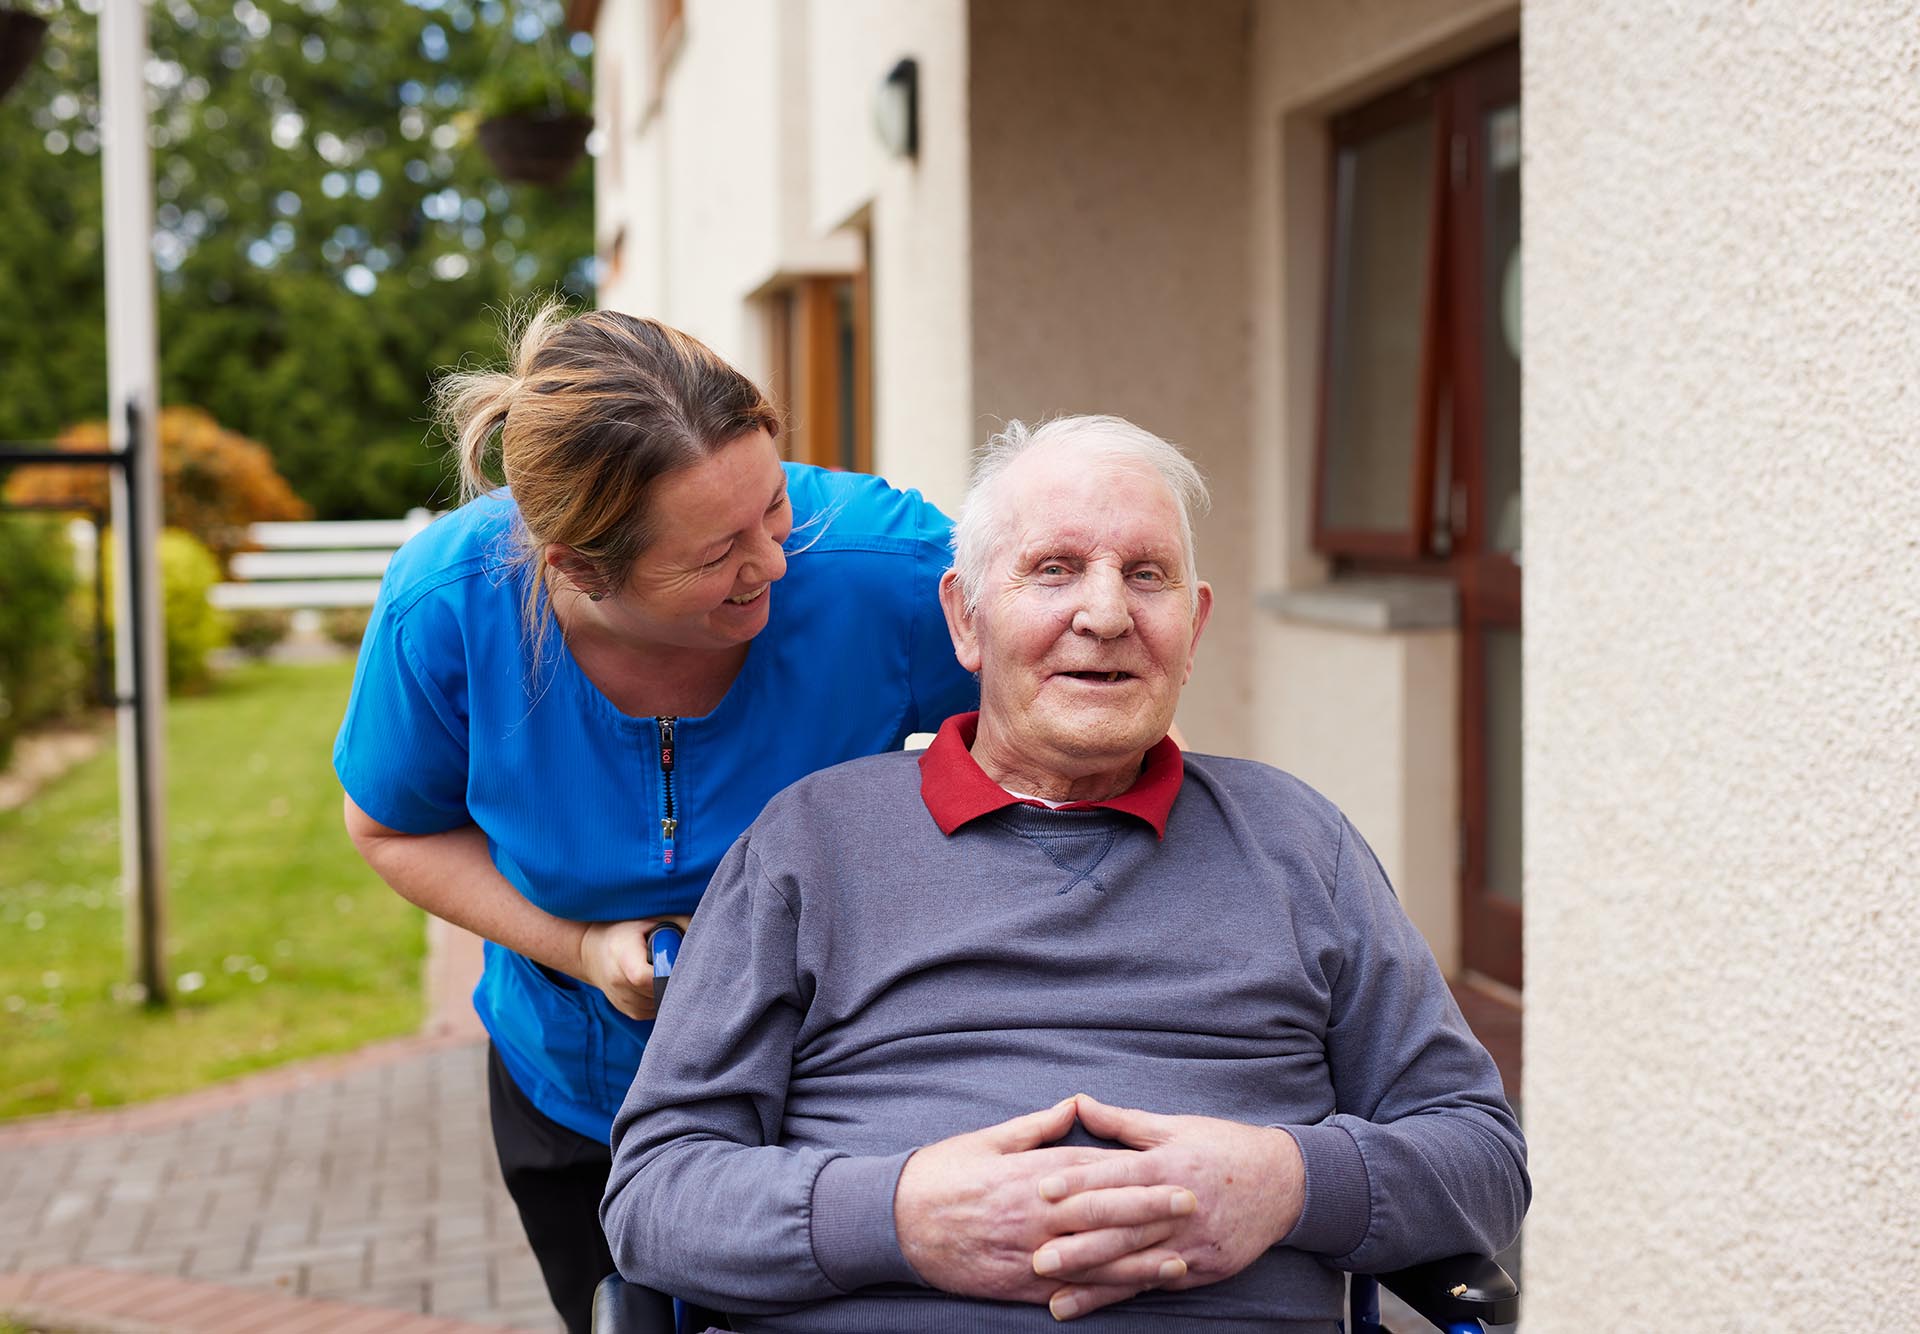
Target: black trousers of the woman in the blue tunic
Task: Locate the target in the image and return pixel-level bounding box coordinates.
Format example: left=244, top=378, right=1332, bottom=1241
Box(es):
left=486, top=1044, right=656, bottom=1334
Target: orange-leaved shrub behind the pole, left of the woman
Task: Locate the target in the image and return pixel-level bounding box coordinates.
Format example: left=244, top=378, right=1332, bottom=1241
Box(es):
left=6, top=407, right=311, bottom=572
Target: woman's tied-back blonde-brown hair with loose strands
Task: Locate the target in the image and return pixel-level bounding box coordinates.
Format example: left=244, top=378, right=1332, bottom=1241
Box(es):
left=434, top=299, right=780, bottom=670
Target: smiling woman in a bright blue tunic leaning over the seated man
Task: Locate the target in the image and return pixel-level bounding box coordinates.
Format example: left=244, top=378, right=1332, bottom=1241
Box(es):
left=334, top=307, right=977, bottom=1330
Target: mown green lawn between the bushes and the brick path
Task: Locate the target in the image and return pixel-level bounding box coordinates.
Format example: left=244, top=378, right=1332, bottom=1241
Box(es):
left=0, top=662, right=426, bottom=1117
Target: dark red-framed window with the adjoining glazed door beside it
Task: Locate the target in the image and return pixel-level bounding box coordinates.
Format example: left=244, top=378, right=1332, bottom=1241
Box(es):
left=1313, top=44, right=1521, bottom=987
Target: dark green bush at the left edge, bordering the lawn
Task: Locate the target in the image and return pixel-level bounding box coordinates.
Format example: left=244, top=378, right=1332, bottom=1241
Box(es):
left=0, top=514, right=86, bottom=766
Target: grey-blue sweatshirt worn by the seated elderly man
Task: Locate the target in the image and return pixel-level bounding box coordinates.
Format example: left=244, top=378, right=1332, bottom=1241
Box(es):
left=601, top=752, right=1530, bottom=1332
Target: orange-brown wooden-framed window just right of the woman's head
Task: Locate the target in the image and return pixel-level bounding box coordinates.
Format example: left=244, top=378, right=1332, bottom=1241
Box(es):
left=768, top=273, right=874, bottom=472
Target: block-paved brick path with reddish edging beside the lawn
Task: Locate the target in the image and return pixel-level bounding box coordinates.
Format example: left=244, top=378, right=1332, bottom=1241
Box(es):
left=0, top=1036, right=559, bottom=1334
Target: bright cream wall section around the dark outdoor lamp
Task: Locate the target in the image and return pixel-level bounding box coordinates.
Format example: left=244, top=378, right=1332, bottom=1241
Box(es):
left=806, top=0, right=979, bottom=511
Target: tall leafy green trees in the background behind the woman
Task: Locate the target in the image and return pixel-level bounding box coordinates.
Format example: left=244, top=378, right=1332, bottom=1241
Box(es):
left=0, top=0, right=593, bottom=518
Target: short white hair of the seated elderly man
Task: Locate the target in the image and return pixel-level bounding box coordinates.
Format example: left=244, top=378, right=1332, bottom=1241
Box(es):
left=954, top=417, right=1212, bottom=610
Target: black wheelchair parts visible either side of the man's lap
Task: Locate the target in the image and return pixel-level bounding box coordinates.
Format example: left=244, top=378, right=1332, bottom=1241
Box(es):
left=593, top=1255, right=1521, bottom=1334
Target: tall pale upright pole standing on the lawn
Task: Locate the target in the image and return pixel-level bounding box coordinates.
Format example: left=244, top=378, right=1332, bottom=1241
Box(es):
left=100, top=0, right=169, bottom=1004
